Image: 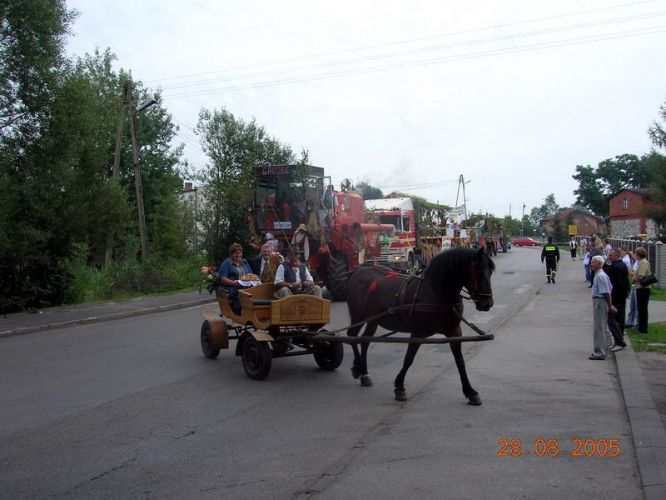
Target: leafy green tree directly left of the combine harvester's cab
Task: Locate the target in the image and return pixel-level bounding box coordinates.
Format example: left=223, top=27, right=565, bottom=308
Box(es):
left=196, top=108, right=294, bottom=263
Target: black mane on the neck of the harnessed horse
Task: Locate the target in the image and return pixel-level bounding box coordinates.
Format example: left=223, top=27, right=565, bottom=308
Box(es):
left=423, top=248, right=495, bottom=291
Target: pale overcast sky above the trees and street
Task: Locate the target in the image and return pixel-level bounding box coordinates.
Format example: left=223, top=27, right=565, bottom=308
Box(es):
left=63, top=0, right=666, bottom=218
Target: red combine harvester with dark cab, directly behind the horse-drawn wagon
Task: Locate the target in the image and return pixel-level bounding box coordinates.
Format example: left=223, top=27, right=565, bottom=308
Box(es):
left=248, top=164, right=393, bottom=300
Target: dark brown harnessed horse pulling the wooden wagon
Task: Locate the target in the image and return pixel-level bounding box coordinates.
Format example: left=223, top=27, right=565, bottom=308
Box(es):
left=346, top=248, right=495, bottom=405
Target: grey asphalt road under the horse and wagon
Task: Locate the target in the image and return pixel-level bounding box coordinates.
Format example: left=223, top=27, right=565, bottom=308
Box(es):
left=0, top=252, right=642, bottom=499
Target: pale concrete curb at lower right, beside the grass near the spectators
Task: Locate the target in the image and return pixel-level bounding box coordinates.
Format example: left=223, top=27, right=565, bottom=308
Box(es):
left=615, top=339, right=666, bottom=500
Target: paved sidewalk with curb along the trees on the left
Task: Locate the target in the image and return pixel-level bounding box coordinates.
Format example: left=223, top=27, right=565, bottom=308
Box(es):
left=0, top=290, right=215, bottom=339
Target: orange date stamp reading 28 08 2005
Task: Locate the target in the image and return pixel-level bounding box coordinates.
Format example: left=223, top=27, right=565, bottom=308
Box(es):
left=497, top=438, right=621, bottom=458
